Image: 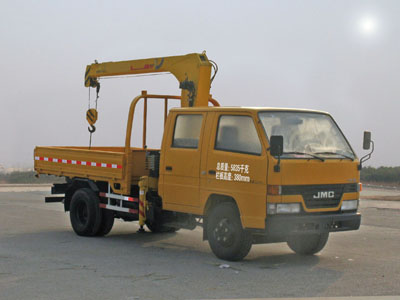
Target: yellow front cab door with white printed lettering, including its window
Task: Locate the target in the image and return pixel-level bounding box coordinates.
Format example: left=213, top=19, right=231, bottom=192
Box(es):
left=201, top=112, right=267, bottom=228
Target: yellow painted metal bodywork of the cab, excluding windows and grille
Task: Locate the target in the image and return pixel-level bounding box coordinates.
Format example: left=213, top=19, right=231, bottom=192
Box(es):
left=158, top=107, right=360, bottom=229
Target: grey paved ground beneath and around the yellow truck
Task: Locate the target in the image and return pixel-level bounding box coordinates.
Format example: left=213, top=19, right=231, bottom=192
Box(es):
left=0, top=187, right=400, bottom=300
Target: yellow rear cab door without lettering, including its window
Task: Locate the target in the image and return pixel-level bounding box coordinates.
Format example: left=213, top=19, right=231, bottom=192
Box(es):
left=160, top=112, right=206, bottom=213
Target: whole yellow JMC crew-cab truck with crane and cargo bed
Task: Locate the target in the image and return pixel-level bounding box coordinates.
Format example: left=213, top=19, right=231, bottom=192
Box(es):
left=34, top=53, right=373, bottom=261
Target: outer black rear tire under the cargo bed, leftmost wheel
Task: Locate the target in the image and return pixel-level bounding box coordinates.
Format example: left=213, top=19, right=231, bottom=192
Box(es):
left=69, top=188, right=101, bottom=236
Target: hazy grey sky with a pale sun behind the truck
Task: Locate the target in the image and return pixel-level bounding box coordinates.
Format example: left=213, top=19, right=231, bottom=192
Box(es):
left=0, top=0, right=400, bottom=167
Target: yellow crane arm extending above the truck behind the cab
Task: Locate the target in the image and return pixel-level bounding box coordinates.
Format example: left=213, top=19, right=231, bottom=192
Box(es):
left=85, top=53, right=211, bottom=107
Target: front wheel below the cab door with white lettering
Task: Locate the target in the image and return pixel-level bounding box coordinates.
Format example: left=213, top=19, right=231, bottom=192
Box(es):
left=206, top=202, right=252, bottom=261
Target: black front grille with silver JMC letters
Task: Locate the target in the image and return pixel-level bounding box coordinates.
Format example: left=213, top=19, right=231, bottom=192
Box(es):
left=282, top=183, right=357, bottom=209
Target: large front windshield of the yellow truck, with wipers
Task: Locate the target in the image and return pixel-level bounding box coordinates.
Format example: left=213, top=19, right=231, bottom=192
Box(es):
left=259, top=111, right=355, bottom=160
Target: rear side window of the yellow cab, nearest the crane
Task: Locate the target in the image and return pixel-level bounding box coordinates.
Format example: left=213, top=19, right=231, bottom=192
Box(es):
left=172, top=115, right=203, bottom=149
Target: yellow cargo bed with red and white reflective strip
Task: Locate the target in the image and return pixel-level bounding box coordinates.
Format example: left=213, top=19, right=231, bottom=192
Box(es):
left=34, top=146, right=149, bottom=195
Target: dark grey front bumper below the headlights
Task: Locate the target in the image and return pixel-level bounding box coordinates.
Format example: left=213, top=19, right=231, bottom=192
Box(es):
left=265, top=212, right=361, bottom=236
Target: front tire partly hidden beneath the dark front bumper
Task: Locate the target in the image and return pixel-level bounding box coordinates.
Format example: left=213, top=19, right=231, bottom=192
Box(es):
left=287, top=232, right=329, bottom=255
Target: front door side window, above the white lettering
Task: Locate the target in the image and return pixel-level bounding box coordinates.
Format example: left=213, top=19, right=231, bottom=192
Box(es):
left=215, top=115, right=261, bottom=155
